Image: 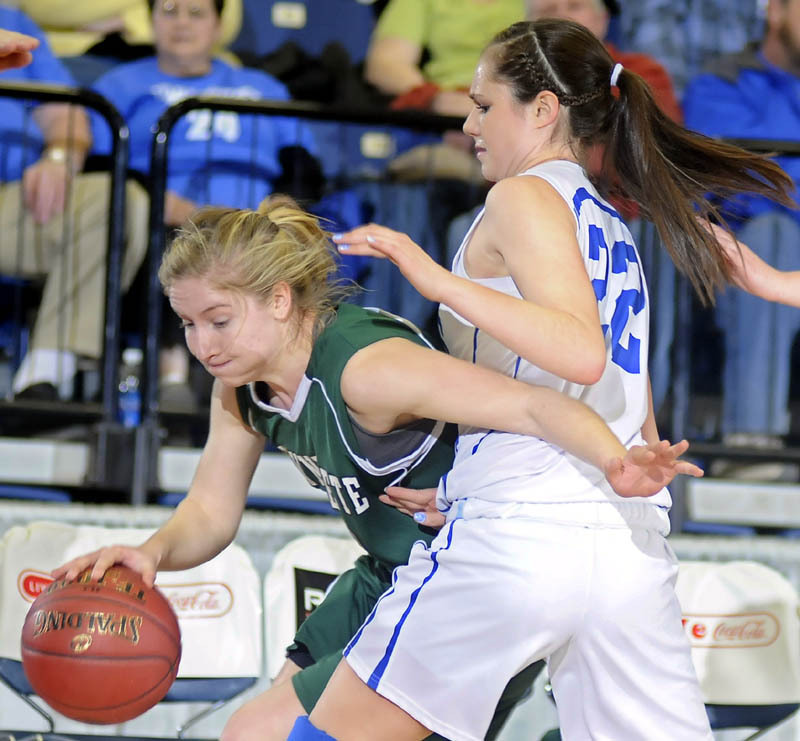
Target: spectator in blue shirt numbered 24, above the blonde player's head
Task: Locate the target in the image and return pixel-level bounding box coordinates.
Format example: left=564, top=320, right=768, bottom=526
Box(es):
left=92, top=0, right=322, bottom=409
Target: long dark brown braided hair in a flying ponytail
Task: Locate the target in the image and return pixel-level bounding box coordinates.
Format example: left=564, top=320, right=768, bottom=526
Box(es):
left=484, top=18, right=795, bottom=303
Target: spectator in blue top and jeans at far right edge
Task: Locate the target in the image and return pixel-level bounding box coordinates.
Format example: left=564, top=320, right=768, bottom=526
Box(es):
left=684, top=0, right=800, bottom=474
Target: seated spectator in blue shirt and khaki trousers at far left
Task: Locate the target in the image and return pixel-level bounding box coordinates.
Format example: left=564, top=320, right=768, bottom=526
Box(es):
left=0, top=6, right=147, bottom=401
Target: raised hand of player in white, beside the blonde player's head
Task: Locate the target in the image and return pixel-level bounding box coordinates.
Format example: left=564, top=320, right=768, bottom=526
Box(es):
left=333, top=224, right=454, bottom=302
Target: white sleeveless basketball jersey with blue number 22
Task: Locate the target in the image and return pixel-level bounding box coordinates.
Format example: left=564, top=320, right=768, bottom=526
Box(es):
left=439, top=161, right=671, bottom=516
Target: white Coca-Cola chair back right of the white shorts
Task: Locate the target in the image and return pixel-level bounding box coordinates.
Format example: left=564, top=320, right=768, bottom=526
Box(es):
left=676, top=561, right=800, bottom=705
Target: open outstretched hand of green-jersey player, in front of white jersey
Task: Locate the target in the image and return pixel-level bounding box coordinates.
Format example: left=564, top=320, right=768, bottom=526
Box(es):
left=604, top=440, right=703, bottom=497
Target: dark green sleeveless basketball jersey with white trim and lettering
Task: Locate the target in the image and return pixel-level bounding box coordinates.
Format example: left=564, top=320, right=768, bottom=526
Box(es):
left=236, top=304, right=457, bottom=569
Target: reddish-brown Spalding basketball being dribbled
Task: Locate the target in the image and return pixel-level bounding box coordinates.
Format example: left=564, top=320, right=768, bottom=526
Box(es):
left=22, top=566, right=181, bottom=724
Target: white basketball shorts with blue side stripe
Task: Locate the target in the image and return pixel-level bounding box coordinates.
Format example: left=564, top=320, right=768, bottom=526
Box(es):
left=345, top=505, right=712, bottom=741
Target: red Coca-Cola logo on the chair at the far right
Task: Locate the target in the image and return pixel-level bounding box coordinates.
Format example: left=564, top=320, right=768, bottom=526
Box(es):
left=683, top=612, right=781, bottom=648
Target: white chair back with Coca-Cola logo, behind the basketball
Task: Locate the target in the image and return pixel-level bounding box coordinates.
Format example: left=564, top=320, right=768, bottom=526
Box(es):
left=0, top=522, right=263, bottom=677
